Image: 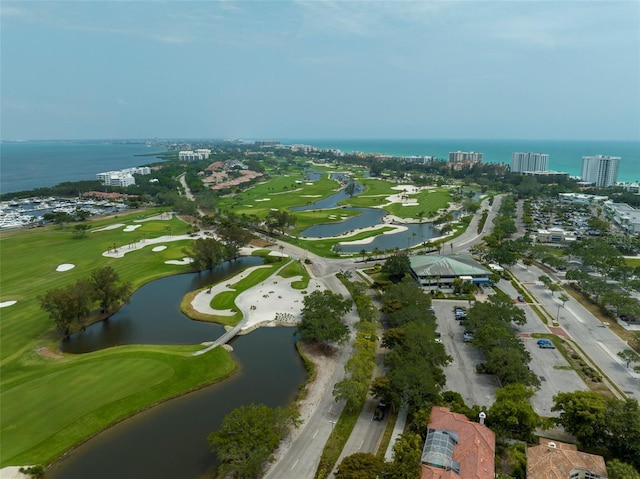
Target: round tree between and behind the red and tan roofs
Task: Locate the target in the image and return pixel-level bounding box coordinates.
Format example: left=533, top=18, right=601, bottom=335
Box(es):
left=487, top=383, right=541, bottom=441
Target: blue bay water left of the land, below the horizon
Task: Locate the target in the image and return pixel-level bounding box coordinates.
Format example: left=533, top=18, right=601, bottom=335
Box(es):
left=0, top=141, right=164, bottom=193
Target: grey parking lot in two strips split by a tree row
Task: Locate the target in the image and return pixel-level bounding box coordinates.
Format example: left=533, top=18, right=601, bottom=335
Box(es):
left=433, top=300, right=587, bottom=416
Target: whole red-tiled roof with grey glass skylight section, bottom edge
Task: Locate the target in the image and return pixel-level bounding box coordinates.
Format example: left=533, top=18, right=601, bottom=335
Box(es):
left=420, top=406, right=496, bottom=479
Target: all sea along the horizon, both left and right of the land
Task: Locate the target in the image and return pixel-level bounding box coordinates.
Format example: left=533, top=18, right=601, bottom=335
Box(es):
left=0, top=139, right=640, bottom=193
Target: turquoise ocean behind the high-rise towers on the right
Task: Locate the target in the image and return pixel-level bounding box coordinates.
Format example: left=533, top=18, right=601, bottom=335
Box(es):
left=279, top=139, right=640, bottom=183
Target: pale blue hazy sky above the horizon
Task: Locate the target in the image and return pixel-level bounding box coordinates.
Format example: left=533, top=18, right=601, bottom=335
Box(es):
left=0, top=0, right=640, bottom=140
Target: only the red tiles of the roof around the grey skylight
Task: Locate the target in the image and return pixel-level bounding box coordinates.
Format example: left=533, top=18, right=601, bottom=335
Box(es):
left=421, top=406, right=496, bottom=479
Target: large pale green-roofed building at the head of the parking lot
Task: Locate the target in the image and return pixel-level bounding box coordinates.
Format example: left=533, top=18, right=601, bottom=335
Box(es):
left=409, top=254, right=491, bottom=292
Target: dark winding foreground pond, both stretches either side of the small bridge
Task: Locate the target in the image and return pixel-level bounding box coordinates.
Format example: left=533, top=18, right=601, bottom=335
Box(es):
left=46, top=257, right=305, bottom=479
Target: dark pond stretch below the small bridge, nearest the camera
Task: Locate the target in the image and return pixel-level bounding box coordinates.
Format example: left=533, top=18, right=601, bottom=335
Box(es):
left=45, top=327, right=305, bottom=479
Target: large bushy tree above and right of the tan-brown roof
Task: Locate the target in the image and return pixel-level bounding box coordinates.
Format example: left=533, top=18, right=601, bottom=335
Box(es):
left=551, top=391, right=606, bottom=447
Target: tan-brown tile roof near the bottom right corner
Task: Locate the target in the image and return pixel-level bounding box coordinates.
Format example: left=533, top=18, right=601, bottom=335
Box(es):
left=527, top=438, right=607, bottom=479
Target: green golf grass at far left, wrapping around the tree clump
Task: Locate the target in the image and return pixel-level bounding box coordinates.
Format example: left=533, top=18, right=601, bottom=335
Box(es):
left=0, top=210, right=240, bottom=467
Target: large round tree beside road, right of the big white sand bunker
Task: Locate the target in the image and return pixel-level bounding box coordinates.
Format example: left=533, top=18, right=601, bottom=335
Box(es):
left=296, top=291, right=351, bottom=347
